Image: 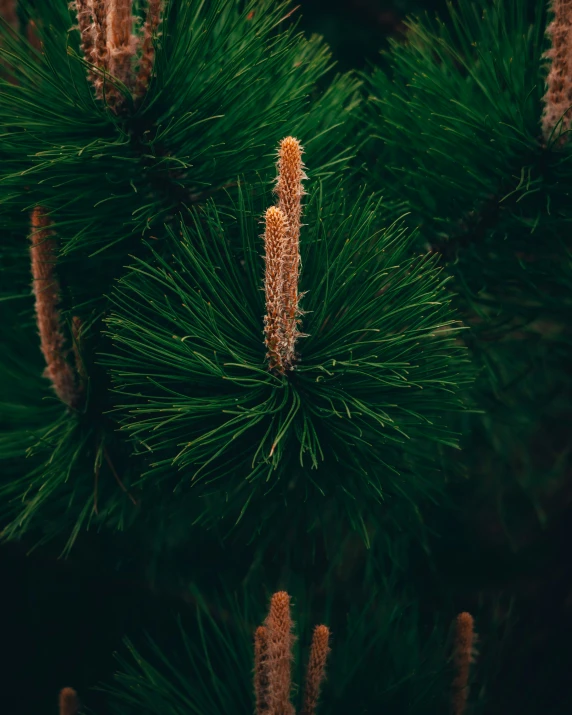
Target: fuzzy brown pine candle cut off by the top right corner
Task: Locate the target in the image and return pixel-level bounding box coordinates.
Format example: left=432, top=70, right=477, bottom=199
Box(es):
left=542, top=0, right=572, bottom=143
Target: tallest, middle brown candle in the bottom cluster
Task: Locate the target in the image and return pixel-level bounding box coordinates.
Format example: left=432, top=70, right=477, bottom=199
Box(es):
left=265, top=591, right=294, bottom=715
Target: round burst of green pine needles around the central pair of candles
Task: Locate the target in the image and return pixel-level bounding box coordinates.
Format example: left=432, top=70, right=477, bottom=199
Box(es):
left=106, top=187, right=467, bottom=536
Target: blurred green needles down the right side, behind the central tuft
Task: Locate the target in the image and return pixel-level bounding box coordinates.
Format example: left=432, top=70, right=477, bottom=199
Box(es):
left=367, top=0, right=572, bottom=532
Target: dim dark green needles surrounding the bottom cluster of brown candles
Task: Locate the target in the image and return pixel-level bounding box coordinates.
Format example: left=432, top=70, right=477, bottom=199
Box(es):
left=104, top=590, right=460, bottom=715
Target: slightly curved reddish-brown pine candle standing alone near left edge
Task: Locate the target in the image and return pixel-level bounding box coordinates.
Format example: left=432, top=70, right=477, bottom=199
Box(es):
left=30, top=207, right=80, bottom=408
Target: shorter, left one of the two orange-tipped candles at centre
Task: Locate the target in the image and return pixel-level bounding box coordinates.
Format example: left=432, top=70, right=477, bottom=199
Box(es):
left=264, top=206, right=287, bottom=373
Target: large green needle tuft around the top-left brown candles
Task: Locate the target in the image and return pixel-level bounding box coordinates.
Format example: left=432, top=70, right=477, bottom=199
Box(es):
left=0, top=0, right=357, bottom=266
